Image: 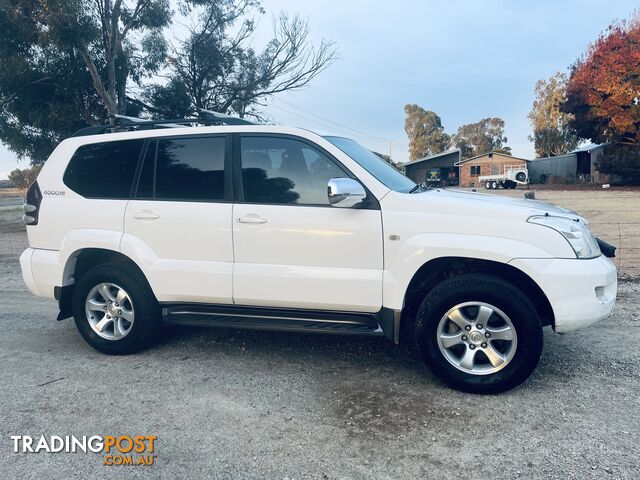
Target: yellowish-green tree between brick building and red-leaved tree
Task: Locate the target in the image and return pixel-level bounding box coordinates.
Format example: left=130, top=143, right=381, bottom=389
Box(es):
left=529, top=72, right=579, bottom=157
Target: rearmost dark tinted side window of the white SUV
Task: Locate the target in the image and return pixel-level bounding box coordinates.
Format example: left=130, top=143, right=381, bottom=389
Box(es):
left=63, top=140, right=144, bottom=199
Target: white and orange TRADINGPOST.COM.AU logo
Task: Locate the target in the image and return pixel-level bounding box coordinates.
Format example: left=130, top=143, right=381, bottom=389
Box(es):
left=11, top=435, right=158, bottom=466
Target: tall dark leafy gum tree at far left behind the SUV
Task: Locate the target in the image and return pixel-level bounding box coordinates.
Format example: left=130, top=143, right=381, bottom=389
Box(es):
left=0, top=0, right=171, bottom=164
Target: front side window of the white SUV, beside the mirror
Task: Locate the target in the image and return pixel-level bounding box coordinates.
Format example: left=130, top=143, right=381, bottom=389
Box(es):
left=240, top=137, right=347, bottom=205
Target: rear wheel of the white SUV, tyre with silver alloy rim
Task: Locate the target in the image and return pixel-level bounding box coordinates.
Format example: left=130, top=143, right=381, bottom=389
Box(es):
left=73, top=263, right=161, bottom=355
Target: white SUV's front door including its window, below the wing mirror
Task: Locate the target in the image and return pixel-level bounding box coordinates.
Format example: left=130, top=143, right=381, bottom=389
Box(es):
left=233, top=135, right=383, bottom=312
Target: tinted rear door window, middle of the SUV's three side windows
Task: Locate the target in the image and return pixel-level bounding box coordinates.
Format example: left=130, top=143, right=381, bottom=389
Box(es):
left=136, top=137, right=226, bottom=201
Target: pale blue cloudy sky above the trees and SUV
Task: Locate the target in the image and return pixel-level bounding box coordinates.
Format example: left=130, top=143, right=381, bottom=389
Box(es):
left=0, top=0, right=638, bottom=178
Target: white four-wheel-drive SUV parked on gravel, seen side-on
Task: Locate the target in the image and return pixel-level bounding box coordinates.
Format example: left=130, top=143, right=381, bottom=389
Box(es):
left=20, top=118, right=617, bottom=392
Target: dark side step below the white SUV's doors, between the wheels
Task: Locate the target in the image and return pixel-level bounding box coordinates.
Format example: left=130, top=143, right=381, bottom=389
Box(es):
left=162, top=304, right=385, bottom=336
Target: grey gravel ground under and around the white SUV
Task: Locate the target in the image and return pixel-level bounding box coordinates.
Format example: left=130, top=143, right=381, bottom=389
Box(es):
left=0, top=207, right=640, bottom=479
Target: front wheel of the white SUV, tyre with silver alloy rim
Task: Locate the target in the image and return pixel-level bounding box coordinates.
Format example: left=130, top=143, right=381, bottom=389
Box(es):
left=415, top=274, right=543, bottom=393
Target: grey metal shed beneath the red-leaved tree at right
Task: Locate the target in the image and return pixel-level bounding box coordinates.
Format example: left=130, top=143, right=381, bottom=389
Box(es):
left=529, top=144, right=607, bottom=183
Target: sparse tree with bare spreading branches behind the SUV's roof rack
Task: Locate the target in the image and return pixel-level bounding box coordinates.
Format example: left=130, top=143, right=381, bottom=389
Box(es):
left=142, top=5, right=336, bottom=117
